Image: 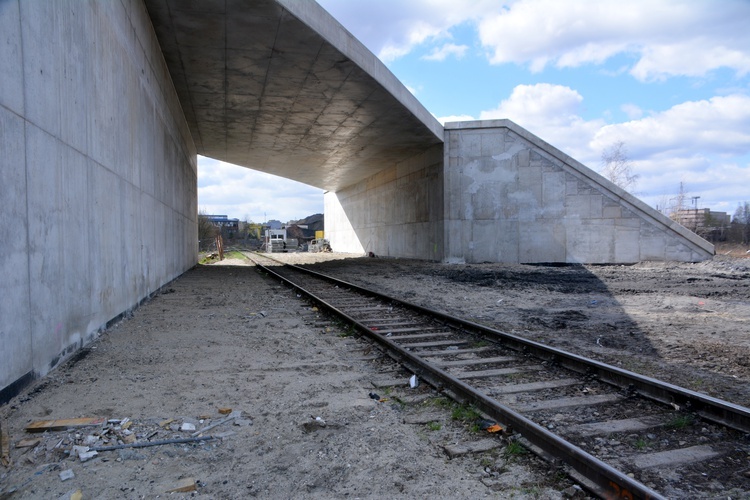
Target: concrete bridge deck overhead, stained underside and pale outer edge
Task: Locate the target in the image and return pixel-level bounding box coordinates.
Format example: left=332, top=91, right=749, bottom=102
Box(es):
left=145, top=0, right=443, bottom=191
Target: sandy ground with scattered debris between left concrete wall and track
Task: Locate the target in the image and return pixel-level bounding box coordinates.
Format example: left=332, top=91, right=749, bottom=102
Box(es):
left=0, top=261, right=576, bottom=499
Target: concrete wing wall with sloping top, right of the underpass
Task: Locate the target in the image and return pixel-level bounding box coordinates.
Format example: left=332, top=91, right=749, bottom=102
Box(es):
left=444, top=120, right=714, bottom=263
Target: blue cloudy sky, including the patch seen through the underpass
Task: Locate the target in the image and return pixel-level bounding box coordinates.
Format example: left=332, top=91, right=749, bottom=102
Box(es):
left=198, top=0, right=750, bottom=222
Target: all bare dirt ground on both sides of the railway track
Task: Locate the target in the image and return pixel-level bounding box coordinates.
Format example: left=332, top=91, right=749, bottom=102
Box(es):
left=0, top=254, right=750, bottom=499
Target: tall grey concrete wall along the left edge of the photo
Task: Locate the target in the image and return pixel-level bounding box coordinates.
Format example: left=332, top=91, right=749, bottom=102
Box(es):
left=0, top=0, right=197, bottom=403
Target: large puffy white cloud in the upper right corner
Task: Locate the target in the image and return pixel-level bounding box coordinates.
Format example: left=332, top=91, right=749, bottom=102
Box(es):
left=479, top=0, right=750, bottom=81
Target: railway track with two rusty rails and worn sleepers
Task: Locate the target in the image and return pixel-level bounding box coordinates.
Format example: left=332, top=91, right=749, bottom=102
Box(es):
left=251, top=254, right=750, bottom=498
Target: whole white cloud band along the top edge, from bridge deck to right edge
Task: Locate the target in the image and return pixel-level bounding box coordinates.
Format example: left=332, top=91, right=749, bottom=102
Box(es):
left=320, top=0, right=750, bottom=81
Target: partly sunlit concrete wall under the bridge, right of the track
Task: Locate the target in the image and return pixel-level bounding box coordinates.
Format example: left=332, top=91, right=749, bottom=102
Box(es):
left=324, top=145, right=443, bottom=260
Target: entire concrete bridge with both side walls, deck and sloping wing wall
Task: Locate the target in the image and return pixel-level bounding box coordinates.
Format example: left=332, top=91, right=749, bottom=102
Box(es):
left=0, top=0, right=713, bottom=403
